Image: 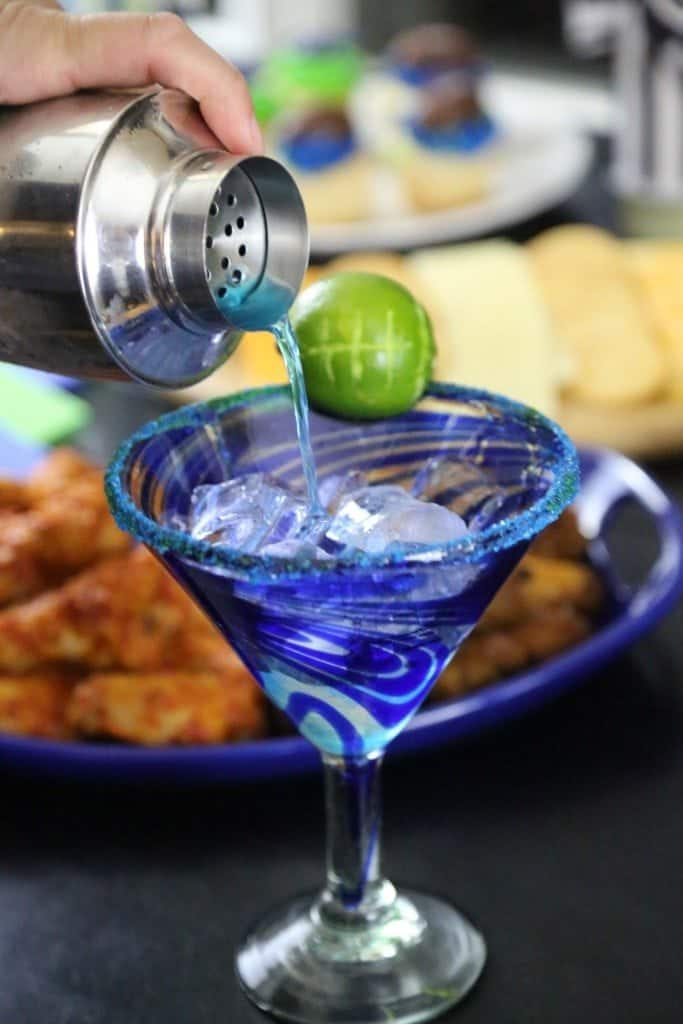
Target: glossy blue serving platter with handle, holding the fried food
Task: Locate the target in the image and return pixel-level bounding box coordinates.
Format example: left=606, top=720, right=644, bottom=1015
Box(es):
left=0, top=450, right=683, bottom=784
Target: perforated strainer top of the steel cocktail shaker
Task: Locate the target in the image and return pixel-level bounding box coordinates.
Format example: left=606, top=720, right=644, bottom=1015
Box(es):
left=76, top=89, right=308, bottom=388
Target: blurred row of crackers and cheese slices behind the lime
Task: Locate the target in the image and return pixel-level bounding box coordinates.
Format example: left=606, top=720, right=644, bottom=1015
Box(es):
left=185, top=230, right=683, bottom=456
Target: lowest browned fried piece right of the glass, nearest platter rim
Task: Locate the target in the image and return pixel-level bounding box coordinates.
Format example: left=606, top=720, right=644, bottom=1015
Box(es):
left=430, top=605, right=591, bottom=700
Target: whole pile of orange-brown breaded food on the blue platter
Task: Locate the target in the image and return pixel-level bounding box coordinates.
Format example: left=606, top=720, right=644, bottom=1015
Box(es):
left=0, top=449, right=602, bottom=746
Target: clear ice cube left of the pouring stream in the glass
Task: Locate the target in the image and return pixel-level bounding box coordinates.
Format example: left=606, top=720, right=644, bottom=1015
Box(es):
left=188, top=473, right=307, bottom=553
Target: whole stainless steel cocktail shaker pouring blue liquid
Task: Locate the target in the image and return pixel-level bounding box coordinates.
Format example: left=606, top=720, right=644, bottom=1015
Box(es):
left=0, top=88, right=308, bottom=388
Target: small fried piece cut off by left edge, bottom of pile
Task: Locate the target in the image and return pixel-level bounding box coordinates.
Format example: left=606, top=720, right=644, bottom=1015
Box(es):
left=0, top=671, right=73, bottom=739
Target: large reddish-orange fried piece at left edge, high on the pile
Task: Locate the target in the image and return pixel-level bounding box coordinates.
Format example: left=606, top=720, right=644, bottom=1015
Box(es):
left=0, top=476, right=131, bottom=606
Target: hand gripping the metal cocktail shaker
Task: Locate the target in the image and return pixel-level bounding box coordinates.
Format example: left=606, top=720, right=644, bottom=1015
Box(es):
left=0, top=0, right=262, bottom=154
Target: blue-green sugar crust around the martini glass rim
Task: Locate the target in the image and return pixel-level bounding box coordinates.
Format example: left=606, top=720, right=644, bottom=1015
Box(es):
left=104, top=383, right=579, bottom=583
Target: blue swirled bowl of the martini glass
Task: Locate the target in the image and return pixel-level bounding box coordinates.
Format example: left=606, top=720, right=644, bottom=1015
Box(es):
left=106, top=385, right=578, bottom=757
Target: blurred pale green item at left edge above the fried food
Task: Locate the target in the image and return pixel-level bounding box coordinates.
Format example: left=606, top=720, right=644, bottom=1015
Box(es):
left=0, top=366, right=92, bottom=444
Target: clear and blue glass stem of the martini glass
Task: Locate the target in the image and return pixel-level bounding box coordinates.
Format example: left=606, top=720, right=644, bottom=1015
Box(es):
left=321, top=753, right=395, bottom=928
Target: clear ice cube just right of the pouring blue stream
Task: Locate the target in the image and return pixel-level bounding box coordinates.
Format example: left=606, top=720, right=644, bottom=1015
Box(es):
left=328, top=484, right=467, bottom=554
